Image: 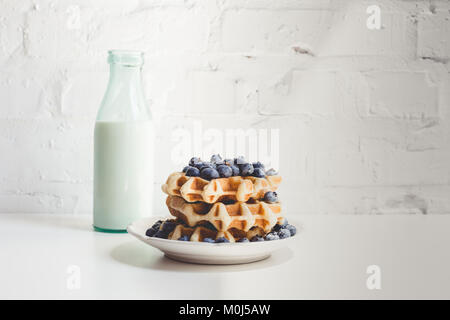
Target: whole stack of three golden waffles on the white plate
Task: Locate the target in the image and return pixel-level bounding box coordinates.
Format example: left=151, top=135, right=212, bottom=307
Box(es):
left=161, top=172, right=284, bottom=242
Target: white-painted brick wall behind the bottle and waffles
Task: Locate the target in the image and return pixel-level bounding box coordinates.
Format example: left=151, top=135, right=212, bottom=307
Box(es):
left=0, top=0, right=450, bottom=214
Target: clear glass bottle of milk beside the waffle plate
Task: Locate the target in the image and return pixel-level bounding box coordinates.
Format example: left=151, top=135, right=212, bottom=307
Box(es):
left=94, top=50, right=153, bottom=232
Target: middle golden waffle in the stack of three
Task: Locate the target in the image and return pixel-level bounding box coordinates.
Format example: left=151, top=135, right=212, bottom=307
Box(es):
left=166, top=196, right=284, bottom=232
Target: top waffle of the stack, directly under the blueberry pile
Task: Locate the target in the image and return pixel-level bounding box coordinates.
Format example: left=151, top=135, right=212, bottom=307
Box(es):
left=162, top=172, right=281, bottom=203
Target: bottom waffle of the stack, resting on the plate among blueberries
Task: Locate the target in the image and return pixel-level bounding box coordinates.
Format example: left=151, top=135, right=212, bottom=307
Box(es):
left=167, top=224, right=265, bottom=242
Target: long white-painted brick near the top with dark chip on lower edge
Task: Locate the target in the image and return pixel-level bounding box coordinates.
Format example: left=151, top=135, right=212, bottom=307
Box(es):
left=222, top=2, right=416, bottom=56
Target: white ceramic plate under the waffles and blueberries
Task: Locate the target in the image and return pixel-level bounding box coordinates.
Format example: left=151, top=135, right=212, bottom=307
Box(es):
left=127, top=217, right=295, bottom=264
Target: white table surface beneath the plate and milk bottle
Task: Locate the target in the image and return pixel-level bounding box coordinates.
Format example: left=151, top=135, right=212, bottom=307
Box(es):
left=0, top=214, right=450, bottom=299
